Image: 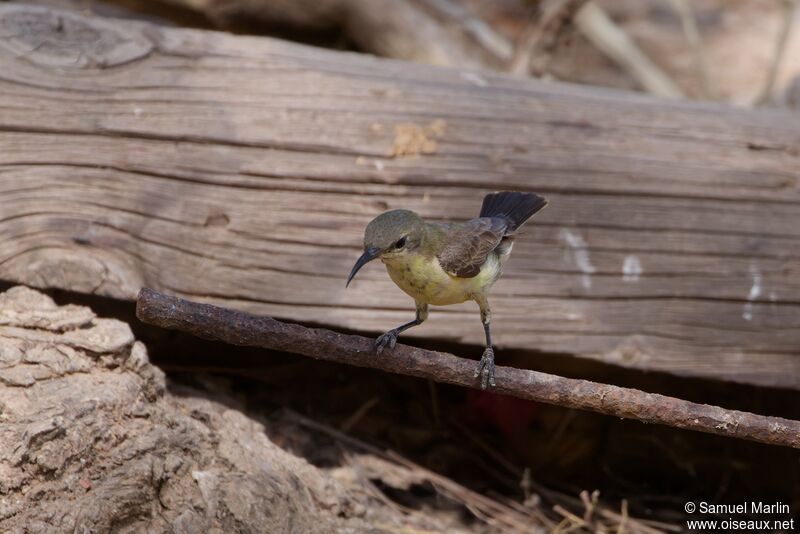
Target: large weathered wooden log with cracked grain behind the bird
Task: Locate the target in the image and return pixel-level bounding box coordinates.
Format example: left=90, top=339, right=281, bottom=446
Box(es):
left=0, top=4, right=800, bottom=388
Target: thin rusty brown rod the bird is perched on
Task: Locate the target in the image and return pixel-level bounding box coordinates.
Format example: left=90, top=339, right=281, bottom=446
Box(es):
left=136, top=288, right=800, bottom=448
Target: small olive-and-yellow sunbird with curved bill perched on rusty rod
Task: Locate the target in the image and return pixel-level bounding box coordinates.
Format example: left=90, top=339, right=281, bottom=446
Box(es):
left=346, top=191, right=547, bottom=389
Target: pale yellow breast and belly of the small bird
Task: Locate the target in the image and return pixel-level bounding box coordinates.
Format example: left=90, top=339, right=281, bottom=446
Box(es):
left=383, top=254, right=500, bottom=306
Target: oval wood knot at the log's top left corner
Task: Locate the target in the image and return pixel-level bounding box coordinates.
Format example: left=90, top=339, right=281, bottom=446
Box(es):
left=0, top=4, right=153, bottom=69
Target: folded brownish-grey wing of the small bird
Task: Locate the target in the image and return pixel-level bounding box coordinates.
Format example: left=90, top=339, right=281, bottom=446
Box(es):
left=436, top=217, right=508, bottom=278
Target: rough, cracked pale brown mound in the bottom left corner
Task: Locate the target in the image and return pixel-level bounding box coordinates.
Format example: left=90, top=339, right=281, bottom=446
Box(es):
left=0, top=287, right=454, bottom=534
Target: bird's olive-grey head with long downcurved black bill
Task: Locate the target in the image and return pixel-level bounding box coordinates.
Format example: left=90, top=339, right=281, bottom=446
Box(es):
left=347, top=210, right=425, bottom=285
